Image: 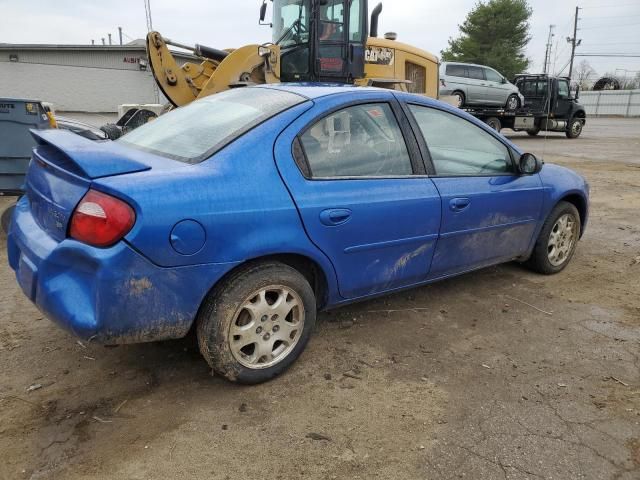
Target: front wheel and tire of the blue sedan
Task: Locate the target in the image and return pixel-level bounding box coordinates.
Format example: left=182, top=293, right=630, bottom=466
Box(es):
left=525, top=202, right=581, bottom=275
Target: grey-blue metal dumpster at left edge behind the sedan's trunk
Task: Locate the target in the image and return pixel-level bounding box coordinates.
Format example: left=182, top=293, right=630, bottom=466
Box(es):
left=0, top=98, right=51, bottom=196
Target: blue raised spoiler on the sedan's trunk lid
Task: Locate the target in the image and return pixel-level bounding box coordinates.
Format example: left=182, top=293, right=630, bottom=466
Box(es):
left=30, top=129, right=151, bottom=179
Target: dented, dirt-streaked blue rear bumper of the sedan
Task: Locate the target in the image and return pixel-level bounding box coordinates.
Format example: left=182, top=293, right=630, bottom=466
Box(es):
left=7, top=197, right=235, bottom=344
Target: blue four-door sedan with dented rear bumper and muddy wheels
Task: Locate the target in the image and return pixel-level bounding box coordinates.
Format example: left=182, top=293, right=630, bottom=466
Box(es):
left=8, top=85, right=589, bottom=383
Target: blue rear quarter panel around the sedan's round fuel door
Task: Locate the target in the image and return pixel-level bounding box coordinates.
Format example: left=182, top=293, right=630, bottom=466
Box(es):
left=96, top=101, right=342, bottom=296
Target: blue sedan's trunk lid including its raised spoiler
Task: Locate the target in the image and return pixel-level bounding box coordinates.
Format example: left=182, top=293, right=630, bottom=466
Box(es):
left=26, top=130, right=151, bottom=241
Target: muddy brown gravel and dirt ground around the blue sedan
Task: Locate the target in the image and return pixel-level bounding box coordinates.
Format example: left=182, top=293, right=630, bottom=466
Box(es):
left=0, top=119, right=640, bottom=480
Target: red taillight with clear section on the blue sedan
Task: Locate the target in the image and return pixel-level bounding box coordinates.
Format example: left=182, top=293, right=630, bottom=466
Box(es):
left=69, top=190, right=136, bottom=247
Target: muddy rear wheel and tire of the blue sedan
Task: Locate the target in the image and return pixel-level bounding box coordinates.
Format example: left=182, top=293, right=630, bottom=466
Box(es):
left=197, top=262, right=316, bottom=384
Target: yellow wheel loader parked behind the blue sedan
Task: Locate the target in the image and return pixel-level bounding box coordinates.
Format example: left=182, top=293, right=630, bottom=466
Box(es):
left=147, top=0, right=438, bottom=107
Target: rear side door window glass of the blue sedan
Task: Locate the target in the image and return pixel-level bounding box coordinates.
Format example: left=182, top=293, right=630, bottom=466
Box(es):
left=300, top=103, right=413, bottom=178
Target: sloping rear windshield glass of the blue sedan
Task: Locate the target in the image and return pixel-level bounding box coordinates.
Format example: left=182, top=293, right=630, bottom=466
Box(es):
left=117, top=88, right=305, bottom=163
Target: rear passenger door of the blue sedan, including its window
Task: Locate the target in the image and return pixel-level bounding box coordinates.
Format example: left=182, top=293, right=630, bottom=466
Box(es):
left=275, top=92, right=441, bottom=298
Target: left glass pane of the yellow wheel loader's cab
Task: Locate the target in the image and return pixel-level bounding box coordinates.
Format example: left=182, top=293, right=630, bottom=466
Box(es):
left=273, top=0, right=309, bottom=47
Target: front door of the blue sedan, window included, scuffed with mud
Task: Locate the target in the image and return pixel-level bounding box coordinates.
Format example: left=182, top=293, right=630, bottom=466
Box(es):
left=410, top=105, right=543, bottom=278
